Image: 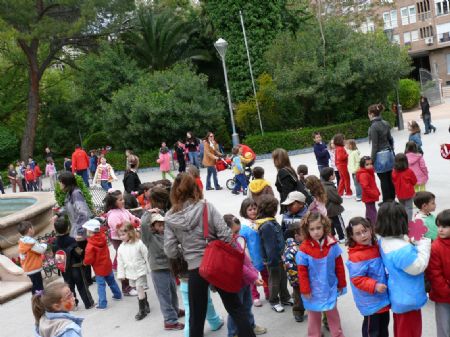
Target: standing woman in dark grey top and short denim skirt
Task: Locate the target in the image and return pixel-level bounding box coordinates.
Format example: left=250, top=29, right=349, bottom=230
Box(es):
left=368, top=103, right=395, bottom=202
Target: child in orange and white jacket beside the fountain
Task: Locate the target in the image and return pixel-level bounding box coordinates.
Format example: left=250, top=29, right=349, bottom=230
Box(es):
left=17, top=221, right=47, bottom=295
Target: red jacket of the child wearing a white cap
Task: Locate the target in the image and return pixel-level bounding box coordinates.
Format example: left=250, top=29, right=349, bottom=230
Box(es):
left=83, top=231, right=112, bottom=276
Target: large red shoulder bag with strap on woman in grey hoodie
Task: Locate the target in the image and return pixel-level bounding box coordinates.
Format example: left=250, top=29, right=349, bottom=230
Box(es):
left=199, top=200, right=245, bottom=293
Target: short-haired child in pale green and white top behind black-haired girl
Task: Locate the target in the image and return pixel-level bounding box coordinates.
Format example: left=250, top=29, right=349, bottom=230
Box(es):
left=414, top=192, right=438, bottom=241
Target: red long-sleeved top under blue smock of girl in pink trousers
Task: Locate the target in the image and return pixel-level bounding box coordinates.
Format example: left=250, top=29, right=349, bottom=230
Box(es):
left=297, top=236, right=347, bottom=294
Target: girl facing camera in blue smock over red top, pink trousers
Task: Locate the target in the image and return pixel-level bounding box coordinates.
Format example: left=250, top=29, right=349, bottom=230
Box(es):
left=295, top=212, right=346, bottom=337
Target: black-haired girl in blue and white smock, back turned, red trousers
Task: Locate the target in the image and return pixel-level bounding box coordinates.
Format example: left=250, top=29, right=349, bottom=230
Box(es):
left=375, top=202, right=431, bottom=337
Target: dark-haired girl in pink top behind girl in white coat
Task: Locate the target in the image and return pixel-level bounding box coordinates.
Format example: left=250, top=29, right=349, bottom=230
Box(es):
left=103, top=191, right=141, bottom=296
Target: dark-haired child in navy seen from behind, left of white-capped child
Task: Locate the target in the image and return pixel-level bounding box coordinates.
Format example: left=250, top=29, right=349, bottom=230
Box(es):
left=256, top=195, right=294, bottom=313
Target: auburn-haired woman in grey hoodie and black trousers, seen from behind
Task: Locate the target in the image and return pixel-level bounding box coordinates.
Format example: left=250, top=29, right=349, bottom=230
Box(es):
left=164, top=173, right=255, bottom=337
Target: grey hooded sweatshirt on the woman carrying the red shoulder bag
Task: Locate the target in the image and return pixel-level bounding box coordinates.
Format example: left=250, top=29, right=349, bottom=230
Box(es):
left=164, top=200, right=232, bottom=270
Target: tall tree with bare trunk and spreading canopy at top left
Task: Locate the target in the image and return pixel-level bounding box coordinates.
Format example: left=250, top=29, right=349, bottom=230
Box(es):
left=0, top=0, right=134, bottom=159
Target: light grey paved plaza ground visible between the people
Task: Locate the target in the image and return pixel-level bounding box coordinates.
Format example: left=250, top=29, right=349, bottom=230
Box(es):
left=0, top=104, right=450, bottom=337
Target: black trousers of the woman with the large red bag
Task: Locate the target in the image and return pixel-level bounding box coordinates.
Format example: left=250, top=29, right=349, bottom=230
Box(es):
left=188, top=268, right=255, bottom=337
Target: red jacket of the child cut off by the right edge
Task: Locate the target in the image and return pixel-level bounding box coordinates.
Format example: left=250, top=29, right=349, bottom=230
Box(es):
left=425, top=237, right=450, bottom=303
